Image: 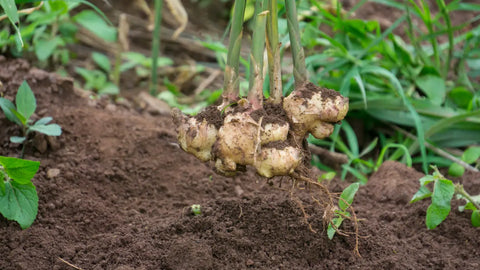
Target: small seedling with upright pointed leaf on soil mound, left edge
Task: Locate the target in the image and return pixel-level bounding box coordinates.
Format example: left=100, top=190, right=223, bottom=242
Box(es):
left=0, top=81, right=62, bottom=156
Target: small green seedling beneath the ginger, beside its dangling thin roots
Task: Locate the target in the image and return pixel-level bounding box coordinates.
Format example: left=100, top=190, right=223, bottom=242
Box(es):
left=327, top=183, right=360, bottom=240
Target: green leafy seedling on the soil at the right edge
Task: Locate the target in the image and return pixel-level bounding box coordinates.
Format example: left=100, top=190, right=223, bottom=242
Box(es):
left=410, top=167, right=480, bottom=229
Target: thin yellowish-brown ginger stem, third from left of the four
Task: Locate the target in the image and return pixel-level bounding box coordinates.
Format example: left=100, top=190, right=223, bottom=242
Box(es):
left=267, top=0, right=283, bottom=104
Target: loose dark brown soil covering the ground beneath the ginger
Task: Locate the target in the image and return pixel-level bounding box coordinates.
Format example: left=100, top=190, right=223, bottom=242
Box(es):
left=0, top=59, right=480, bottom=270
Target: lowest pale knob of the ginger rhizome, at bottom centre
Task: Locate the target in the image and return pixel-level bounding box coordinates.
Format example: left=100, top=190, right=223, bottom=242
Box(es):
left=255, top=146, right=302, bottom=178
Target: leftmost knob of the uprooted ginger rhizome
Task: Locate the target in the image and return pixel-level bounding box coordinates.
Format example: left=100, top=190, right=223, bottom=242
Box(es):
left=172, top=108, right=218, bottom=161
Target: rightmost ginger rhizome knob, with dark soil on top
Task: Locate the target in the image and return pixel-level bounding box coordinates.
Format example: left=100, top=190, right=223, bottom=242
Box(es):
left=283, top=82, right=348, bottom=139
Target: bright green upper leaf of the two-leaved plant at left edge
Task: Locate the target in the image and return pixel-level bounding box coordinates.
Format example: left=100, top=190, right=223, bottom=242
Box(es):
left=0, top=157, right=40, bottom=184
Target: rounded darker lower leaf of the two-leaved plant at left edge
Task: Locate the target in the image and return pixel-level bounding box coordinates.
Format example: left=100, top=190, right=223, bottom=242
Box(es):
left=0, top=181, right=38, bottom=229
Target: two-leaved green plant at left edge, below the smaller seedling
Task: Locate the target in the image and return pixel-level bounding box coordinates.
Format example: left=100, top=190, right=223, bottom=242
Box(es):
left=0, top=156, right=40, bottom=229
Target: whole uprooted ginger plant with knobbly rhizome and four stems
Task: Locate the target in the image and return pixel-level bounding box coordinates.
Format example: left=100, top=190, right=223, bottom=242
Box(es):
left=172, top=0, right=348, bottom=178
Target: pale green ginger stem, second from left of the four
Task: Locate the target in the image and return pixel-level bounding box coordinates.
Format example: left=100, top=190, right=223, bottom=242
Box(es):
left=248, top=0, right=268, bottom=110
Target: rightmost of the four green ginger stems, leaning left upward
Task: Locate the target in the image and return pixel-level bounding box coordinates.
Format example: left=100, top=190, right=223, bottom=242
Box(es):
left=285, top=0, right=307, bottom=87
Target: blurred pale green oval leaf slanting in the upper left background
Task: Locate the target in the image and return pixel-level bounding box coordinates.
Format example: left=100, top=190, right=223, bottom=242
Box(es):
left=73, top=10, right=117, bottom=42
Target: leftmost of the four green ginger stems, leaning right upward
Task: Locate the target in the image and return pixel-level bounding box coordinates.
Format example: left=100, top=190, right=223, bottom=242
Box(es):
left=222, top=0, right=246, bottom=103
